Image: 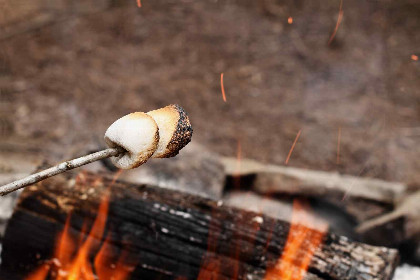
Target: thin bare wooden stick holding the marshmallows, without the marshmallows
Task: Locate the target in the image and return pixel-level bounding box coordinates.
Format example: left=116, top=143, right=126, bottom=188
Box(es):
left=0, top=148, right=124, bottom=196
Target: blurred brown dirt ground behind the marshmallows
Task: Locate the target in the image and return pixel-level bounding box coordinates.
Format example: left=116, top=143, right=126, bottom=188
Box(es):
left=0, top=0, right=420, bottom=184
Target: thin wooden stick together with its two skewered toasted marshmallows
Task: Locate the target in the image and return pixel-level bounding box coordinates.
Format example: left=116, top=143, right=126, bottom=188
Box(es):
left=0, top=105, right=192, bottom=196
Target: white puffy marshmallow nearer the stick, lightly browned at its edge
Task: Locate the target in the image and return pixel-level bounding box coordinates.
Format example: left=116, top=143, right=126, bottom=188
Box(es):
left=105, top=112, right=159, bottom=169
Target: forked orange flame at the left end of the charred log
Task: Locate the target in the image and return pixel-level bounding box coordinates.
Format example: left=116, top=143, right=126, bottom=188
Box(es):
left=25, top=172, right=134, bottom=280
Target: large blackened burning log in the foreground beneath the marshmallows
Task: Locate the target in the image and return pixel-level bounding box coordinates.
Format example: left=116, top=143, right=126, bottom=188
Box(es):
left=1, top=172, right=398, bottom=280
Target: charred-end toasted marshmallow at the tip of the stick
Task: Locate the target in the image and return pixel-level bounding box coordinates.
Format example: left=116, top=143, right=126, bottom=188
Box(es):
left=147, top=104, right=193, bottom=158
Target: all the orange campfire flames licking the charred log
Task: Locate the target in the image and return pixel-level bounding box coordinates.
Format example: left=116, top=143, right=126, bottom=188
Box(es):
left=17, top=192, right=327, bottom=280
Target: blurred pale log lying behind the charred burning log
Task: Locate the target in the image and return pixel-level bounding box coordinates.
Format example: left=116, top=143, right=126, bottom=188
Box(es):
left=223, top=158, right=408, bottom=223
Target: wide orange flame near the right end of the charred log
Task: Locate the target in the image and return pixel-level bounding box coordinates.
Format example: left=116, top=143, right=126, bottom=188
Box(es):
left=264, top=200, right=327, bottom=280
